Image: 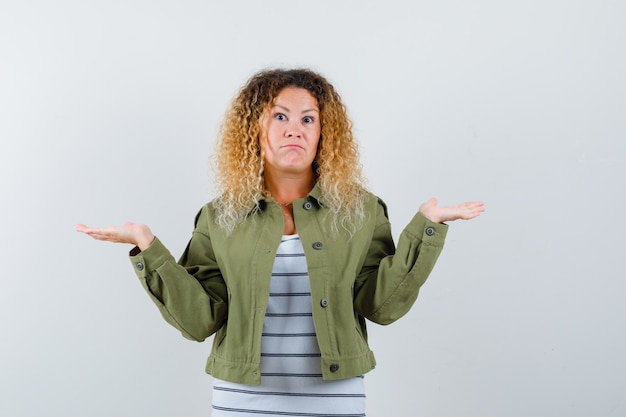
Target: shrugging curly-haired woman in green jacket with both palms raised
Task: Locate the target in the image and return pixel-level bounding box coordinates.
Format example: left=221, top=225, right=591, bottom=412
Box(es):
left=77, top=69, right=483, bottom=417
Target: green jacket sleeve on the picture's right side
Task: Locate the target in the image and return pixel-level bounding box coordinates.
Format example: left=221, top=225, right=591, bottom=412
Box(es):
left=354, top=199, right=448, bottom=324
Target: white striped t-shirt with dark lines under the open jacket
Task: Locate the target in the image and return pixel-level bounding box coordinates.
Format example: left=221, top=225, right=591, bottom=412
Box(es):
left=211, top=235, right=365, bottom=417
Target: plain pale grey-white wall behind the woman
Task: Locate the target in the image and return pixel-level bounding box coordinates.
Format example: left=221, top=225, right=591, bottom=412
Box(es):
left=0, top=0, right=626, bottom=417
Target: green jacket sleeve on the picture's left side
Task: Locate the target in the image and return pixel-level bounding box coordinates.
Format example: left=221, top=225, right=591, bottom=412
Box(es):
left=130, top=209, right=228, bottom=342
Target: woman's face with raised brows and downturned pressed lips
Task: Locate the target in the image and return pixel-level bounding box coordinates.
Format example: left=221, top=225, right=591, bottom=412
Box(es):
left=261, top=87, right=321, bottom=177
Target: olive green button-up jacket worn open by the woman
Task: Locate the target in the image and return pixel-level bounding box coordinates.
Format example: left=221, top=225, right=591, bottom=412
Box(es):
left=130, top=187, right=447, bottom=385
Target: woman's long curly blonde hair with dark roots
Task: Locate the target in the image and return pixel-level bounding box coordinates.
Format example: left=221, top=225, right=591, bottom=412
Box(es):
left=211, top=69, right=367, bottom=235
